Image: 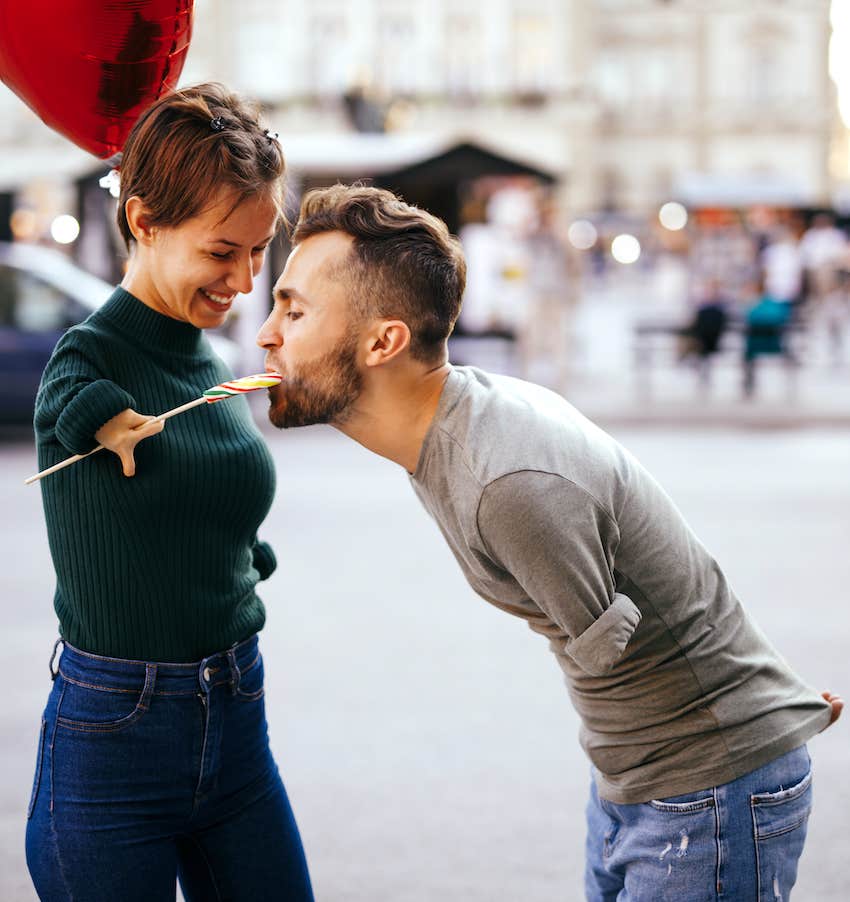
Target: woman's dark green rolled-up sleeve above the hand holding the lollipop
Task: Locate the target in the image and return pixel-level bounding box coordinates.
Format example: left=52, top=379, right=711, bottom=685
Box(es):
left=35, top=330, right=136, bottom=454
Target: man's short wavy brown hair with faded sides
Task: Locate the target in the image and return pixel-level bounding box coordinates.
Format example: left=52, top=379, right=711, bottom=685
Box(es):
left=292, top=185, right=466, bottom=363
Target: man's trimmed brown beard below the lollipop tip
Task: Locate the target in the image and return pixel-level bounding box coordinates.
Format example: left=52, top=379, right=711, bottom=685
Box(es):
left=269, top=336, right=363, bottom=429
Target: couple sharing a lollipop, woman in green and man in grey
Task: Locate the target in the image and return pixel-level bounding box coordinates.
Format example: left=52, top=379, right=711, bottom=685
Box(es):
left=27, top=85, right=842, bottom=902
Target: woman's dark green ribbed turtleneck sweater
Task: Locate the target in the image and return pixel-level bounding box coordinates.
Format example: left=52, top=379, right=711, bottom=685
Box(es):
left=35, top=288, right=275, bottom=662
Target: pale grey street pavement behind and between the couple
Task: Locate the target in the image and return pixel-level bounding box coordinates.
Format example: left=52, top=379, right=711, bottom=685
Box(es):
left=0, top=418, right=850, bottom=902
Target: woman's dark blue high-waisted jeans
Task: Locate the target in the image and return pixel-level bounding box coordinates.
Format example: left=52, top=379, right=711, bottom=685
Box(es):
left=27, top=636, right=313, bottom=902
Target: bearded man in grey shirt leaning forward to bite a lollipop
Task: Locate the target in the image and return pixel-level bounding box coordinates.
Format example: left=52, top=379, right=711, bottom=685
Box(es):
left=258, top=185, right=842, bottom=902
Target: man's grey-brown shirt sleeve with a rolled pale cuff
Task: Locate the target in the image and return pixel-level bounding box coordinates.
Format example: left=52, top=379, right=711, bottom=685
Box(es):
left=478, top=471, right=641, bottom=676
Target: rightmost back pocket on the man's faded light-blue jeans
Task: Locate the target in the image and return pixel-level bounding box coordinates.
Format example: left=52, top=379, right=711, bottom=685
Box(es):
left=750, top=770, right=812, bottom=902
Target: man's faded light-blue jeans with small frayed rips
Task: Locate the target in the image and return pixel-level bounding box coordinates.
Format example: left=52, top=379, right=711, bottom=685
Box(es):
left=585, top=746, right=812, bottom=902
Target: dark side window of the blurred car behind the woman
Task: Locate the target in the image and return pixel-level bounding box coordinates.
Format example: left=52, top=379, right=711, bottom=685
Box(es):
left=0, top=265, right=84, bottom=332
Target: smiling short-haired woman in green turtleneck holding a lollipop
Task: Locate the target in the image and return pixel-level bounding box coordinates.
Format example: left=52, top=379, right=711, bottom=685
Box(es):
left=27, top=85, right=312, bottom=902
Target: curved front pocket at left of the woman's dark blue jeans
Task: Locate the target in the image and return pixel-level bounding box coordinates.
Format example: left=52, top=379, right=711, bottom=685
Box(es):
left=56, top=664, right=156, bottom=733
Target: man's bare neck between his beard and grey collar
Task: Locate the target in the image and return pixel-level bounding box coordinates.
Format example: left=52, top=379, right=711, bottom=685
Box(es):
left=333, top=363, right=451, bottom=473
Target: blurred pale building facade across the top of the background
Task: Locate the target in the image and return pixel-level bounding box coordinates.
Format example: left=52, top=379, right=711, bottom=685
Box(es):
left=0, top=0, right=846, bottom=224
